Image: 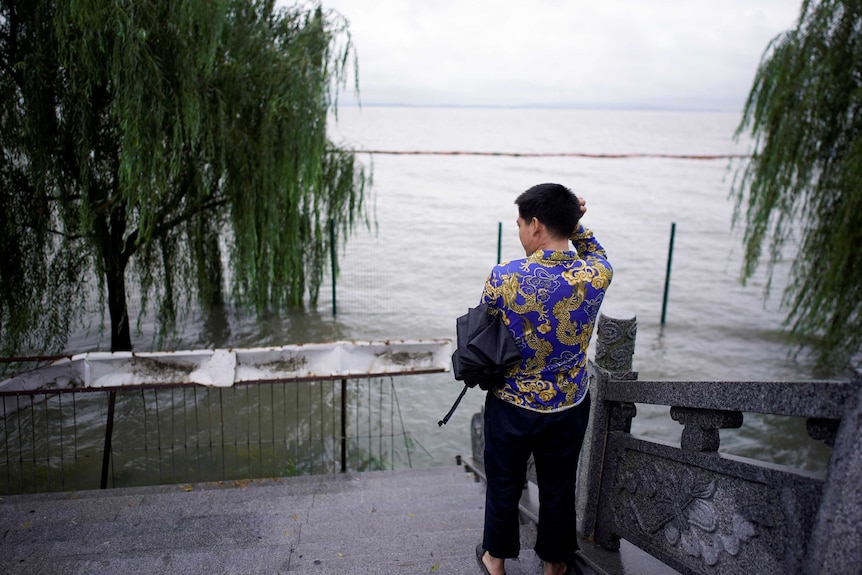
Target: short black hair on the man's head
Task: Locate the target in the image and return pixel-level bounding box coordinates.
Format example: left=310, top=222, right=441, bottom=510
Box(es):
left=515, top=184, right=581, bottom=239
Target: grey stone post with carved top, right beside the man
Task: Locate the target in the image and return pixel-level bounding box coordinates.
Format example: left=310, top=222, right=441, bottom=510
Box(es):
left=577, top=313, right=637, bottom=546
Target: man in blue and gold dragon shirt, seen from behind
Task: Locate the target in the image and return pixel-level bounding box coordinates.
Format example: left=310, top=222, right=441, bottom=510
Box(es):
left=476, top=184, right=613, bottom=575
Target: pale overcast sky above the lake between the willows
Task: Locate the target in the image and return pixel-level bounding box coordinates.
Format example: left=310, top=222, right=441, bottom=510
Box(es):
left=296, top=0, right=801, bottom=110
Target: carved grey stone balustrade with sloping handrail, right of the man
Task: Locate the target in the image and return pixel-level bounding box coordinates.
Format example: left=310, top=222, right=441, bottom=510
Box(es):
left=471, top=315, right=862, bottom=575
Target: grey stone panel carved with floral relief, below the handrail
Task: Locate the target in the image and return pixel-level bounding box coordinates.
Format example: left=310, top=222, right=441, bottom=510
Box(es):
left=613, top=450, right=810, bottom=575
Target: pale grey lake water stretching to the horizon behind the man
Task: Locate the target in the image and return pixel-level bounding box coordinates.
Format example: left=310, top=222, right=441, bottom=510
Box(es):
left=64, top=107, right=827, bottom=476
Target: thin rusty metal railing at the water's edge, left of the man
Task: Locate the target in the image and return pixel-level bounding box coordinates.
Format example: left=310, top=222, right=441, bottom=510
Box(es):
left=0, top=343, right=448, bottom=494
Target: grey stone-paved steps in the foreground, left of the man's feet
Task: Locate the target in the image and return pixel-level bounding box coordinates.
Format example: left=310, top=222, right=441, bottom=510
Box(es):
left=0, top=465, right=552, bottom=575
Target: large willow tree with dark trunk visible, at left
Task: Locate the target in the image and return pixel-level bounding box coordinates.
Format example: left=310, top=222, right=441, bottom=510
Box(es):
left=0, top=0, right=367, bottom=354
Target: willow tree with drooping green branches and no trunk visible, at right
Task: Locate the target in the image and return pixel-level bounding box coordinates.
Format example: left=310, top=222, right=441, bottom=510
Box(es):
left=735, top=0, right=862, bottom=370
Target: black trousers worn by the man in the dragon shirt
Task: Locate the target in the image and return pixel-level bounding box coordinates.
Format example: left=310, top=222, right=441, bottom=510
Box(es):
left=482, top=392, right=590, bottom=563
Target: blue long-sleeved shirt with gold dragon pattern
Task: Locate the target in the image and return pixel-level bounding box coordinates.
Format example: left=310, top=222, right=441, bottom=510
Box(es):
left=482, top=225, right=613, bottom=412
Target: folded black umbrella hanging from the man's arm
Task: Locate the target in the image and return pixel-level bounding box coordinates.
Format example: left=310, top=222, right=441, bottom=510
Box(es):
left=437, top=304, right=521, bottom=425
